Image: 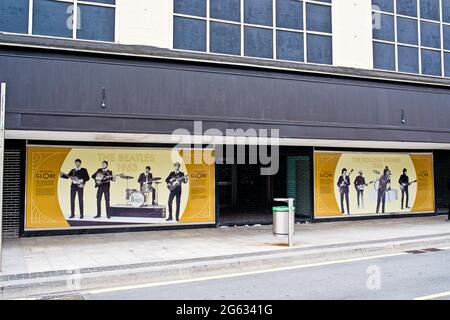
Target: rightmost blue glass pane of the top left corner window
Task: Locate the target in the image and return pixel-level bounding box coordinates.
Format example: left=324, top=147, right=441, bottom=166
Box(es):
left=77, top=5, right=115, bottom=41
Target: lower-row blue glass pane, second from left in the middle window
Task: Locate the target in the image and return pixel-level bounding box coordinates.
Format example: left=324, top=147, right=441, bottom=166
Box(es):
left=210, top=22, right=241, bottom=55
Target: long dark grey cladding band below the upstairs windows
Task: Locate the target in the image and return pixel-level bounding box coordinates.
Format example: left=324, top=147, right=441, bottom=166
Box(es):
left=0, top=49, right=450, bottom=142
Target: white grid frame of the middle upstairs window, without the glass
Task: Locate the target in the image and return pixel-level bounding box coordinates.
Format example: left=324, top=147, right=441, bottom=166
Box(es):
left=170, top=0, right=334, bottom=65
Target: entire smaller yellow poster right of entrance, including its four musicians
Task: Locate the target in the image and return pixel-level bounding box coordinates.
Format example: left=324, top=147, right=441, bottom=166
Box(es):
left=314, top=151, right=434, bottom=218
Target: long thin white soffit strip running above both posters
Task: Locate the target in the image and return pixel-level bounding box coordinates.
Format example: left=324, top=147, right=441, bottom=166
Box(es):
left=6, top=130, right=450, bottom=150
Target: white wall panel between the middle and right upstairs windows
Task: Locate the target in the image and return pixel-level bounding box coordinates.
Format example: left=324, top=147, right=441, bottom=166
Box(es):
left=333, top=0, right=373, bottom=69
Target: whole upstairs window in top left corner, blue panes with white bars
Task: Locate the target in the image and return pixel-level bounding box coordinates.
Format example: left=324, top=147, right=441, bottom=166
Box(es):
left=0, top=0, right=116, bottom=42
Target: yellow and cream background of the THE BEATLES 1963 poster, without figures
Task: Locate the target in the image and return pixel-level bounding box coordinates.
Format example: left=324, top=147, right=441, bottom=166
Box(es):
left=25, top=146, right=215, bottom=229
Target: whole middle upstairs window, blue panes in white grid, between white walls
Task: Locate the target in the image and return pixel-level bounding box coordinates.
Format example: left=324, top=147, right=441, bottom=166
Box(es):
left=173, top=0, right=333, bottom=64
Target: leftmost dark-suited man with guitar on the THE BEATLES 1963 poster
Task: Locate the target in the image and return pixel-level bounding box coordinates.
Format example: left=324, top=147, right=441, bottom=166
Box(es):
left=60, top=159, right=89, bottom=219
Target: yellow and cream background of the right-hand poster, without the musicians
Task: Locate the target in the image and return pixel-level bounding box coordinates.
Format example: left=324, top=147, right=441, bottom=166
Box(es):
left=314, top=151, right=434, bottom=218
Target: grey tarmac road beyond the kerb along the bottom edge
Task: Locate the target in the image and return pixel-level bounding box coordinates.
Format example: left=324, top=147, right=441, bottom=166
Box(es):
left=83, top=248, right=450, bottom=300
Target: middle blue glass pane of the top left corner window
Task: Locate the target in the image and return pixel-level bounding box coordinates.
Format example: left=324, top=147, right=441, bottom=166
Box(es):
left=33, top=0, right=74, bottom=38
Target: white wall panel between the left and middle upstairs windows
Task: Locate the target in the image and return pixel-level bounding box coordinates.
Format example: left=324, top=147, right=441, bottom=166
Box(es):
left=117, top=0, right=173, bottom=48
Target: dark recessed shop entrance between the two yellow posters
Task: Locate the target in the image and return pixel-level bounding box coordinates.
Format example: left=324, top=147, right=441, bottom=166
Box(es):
left=216, top=148, right=313, bottom=225
